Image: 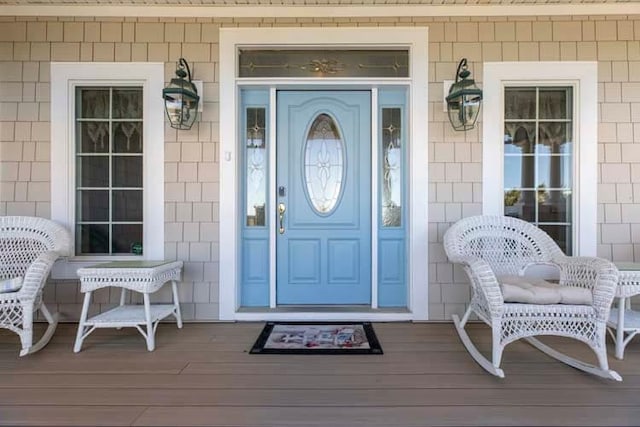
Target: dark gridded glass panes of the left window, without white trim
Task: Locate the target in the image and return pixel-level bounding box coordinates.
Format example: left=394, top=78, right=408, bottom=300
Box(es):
left=75, top=86, right=143, bottom=255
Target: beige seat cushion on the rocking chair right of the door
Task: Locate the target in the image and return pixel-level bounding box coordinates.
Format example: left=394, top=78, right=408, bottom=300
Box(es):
left=498, top=276, right=593, bottom=305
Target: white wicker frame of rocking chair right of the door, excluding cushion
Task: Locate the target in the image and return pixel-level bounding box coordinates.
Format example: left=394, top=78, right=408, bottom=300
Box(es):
left=444, top=216, right=622, bottom=381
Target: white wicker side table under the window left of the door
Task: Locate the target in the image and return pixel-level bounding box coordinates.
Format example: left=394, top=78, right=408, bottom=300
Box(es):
left=73, top=261, right=182, bottom=353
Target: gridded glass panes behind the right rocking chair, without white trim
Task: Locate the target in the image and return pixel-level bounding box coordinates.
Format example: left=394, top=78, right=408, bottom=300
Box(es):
left=503, top=86, right=574, bottom=255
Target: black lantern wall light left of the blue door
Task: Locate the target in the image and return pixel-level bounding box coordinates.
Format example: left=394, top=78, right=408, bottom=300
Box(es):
left=162, top=58, right=200, bottom=130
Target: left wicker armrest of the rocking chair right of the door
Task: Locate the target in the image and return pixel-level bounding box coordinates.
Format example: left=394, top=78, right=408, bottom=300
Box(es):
left=457, top=258, right=504, bottom=317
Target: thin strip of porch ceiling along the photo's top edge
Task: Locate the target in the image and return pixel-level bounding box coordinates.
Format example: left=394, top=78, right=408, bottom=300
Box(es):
left=0, top=0, right=640, bottom=6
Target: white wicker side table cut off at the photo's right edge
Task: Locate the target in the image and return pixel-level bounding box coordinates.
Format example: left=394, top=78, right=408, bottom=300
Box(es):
left=607, top=262, right=640, bottom=359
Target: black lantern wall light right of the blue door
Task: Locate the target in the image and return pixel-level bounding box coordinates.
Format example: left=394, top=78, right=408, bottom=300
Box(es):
left=446, top=58, right=482, bottom=130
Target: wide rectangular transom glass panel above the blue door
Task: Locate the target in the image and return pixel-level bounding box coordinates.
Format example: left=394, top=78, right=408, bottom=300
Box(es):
left=238, top=49, right=409, bottom=78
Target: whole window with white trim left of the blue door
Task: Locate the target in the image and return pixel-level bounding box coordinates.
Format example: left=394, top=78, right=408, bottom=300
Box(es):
left=51, top=63, right=164, bottom=260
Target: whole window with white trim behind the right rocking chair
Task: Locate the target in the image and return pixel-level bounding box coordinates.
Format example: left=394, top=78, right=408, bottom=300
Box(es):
left=483, top=62, right=598, bottom=255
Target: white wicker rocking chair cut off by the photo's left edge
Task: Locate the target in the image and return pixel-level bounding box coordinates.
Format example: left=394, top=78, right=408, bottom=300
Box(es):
left=0, top=216, right=71, bottom=356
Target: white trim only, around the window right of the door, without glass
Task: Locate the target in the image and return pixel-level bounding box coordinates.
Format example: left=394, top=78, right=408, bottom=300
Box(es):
left=482, top=62, right=598, bottom=256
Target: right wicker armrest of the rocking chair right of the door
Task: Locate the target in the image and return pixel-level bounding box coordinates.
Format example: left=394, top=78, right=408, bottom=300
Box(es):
left=554, top=257, right=619, bottom=319
